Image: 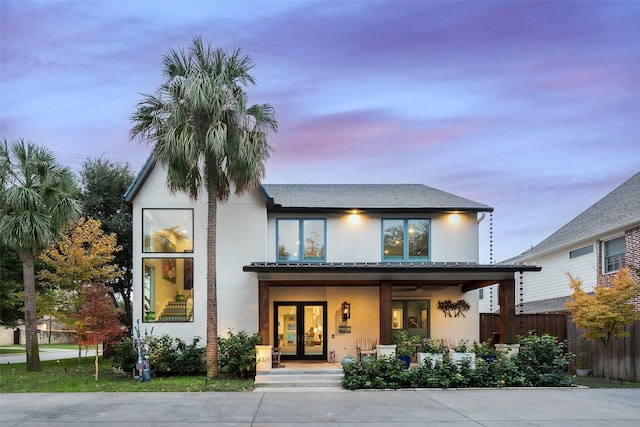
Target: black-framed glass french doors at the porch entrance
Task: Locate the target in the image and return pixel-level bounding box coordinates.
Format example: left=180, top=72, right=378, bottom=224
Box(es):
left=273, top=302, right=327, bottom=360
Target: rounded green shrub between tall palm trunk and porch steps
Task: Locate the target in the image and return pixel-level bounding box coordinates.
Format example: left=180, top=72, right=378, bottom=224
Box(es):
left=218, top=329, right=262, bottom=378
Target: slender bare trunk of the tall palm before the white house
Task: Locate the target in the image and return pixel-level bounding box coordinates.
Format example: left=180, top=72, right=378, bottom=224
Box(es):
left=206, top=174, right=218, bottom=378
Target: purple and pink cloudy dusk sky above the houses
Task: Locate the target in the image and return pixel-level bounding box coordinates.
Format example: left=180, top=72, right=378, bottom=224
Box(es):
left=0, top=0, right=640, bottom=262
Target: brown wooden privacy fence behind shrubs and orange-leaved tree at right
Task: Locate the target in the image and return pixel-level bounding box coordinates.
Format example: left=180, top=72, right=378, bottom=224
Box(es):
left=480, top=313, right=640, bottom=381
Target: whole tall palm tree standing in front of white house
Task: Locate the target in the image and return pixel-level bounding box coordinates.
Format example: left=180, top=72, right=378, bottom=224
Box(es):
left=130, top=37, right=278, bottom=377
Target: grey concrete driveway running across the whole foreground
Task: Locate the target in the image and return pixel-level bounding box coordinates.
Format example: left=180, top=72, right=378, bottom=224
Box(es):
left=0, top=388, right=640, bottom=427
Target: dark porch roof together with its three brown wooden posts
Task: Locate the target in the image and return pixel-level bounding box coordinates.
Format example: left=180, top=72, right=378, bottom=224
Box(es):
left=243, top=262, right=542, bottom=344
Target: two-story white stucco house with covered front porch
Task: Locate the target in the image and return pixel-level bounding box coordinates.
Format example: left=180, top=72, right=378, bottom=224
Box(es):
left=125, top=159, right=540, bottom=360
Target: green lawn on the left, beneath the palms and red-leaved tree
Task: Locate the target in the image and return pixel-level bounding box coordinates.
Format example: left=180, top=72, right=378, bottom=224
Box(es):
left=0, top=356, right=253, bottom=393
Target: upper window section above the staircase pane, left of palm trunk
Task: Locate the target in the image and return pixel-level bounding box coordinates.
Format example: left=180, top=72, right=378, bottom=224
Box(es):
left=142, top=209, right=193, bottom=253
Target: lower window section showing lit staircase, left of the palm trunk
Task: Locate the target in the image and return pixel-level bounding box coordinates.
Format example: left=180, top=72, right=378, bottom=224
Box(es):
left=142, top=258, right=193, bottom=322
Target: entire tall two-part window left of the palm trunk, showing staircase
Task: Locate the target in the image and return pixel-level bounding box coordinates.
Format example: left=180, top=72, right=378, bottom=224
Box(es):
left=142, top=209, right=193, bottom=322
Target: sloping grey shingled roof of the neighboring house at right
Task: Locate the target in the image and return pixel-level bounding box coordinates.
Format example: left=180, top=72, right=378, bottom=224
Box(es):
left=504, top=172, right=640, bottom=263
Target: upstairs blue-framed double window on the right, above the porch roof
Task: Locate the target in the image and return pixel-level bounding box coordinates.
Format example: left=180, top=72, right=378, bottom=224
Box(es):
left=382, top=219, right=430, bottom=261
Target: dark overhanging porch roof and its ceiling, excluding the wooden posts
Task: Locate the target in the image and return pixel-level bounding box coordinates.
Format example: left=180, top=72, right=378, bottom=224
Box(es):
left=243, top=262, right=542, bottom=292
